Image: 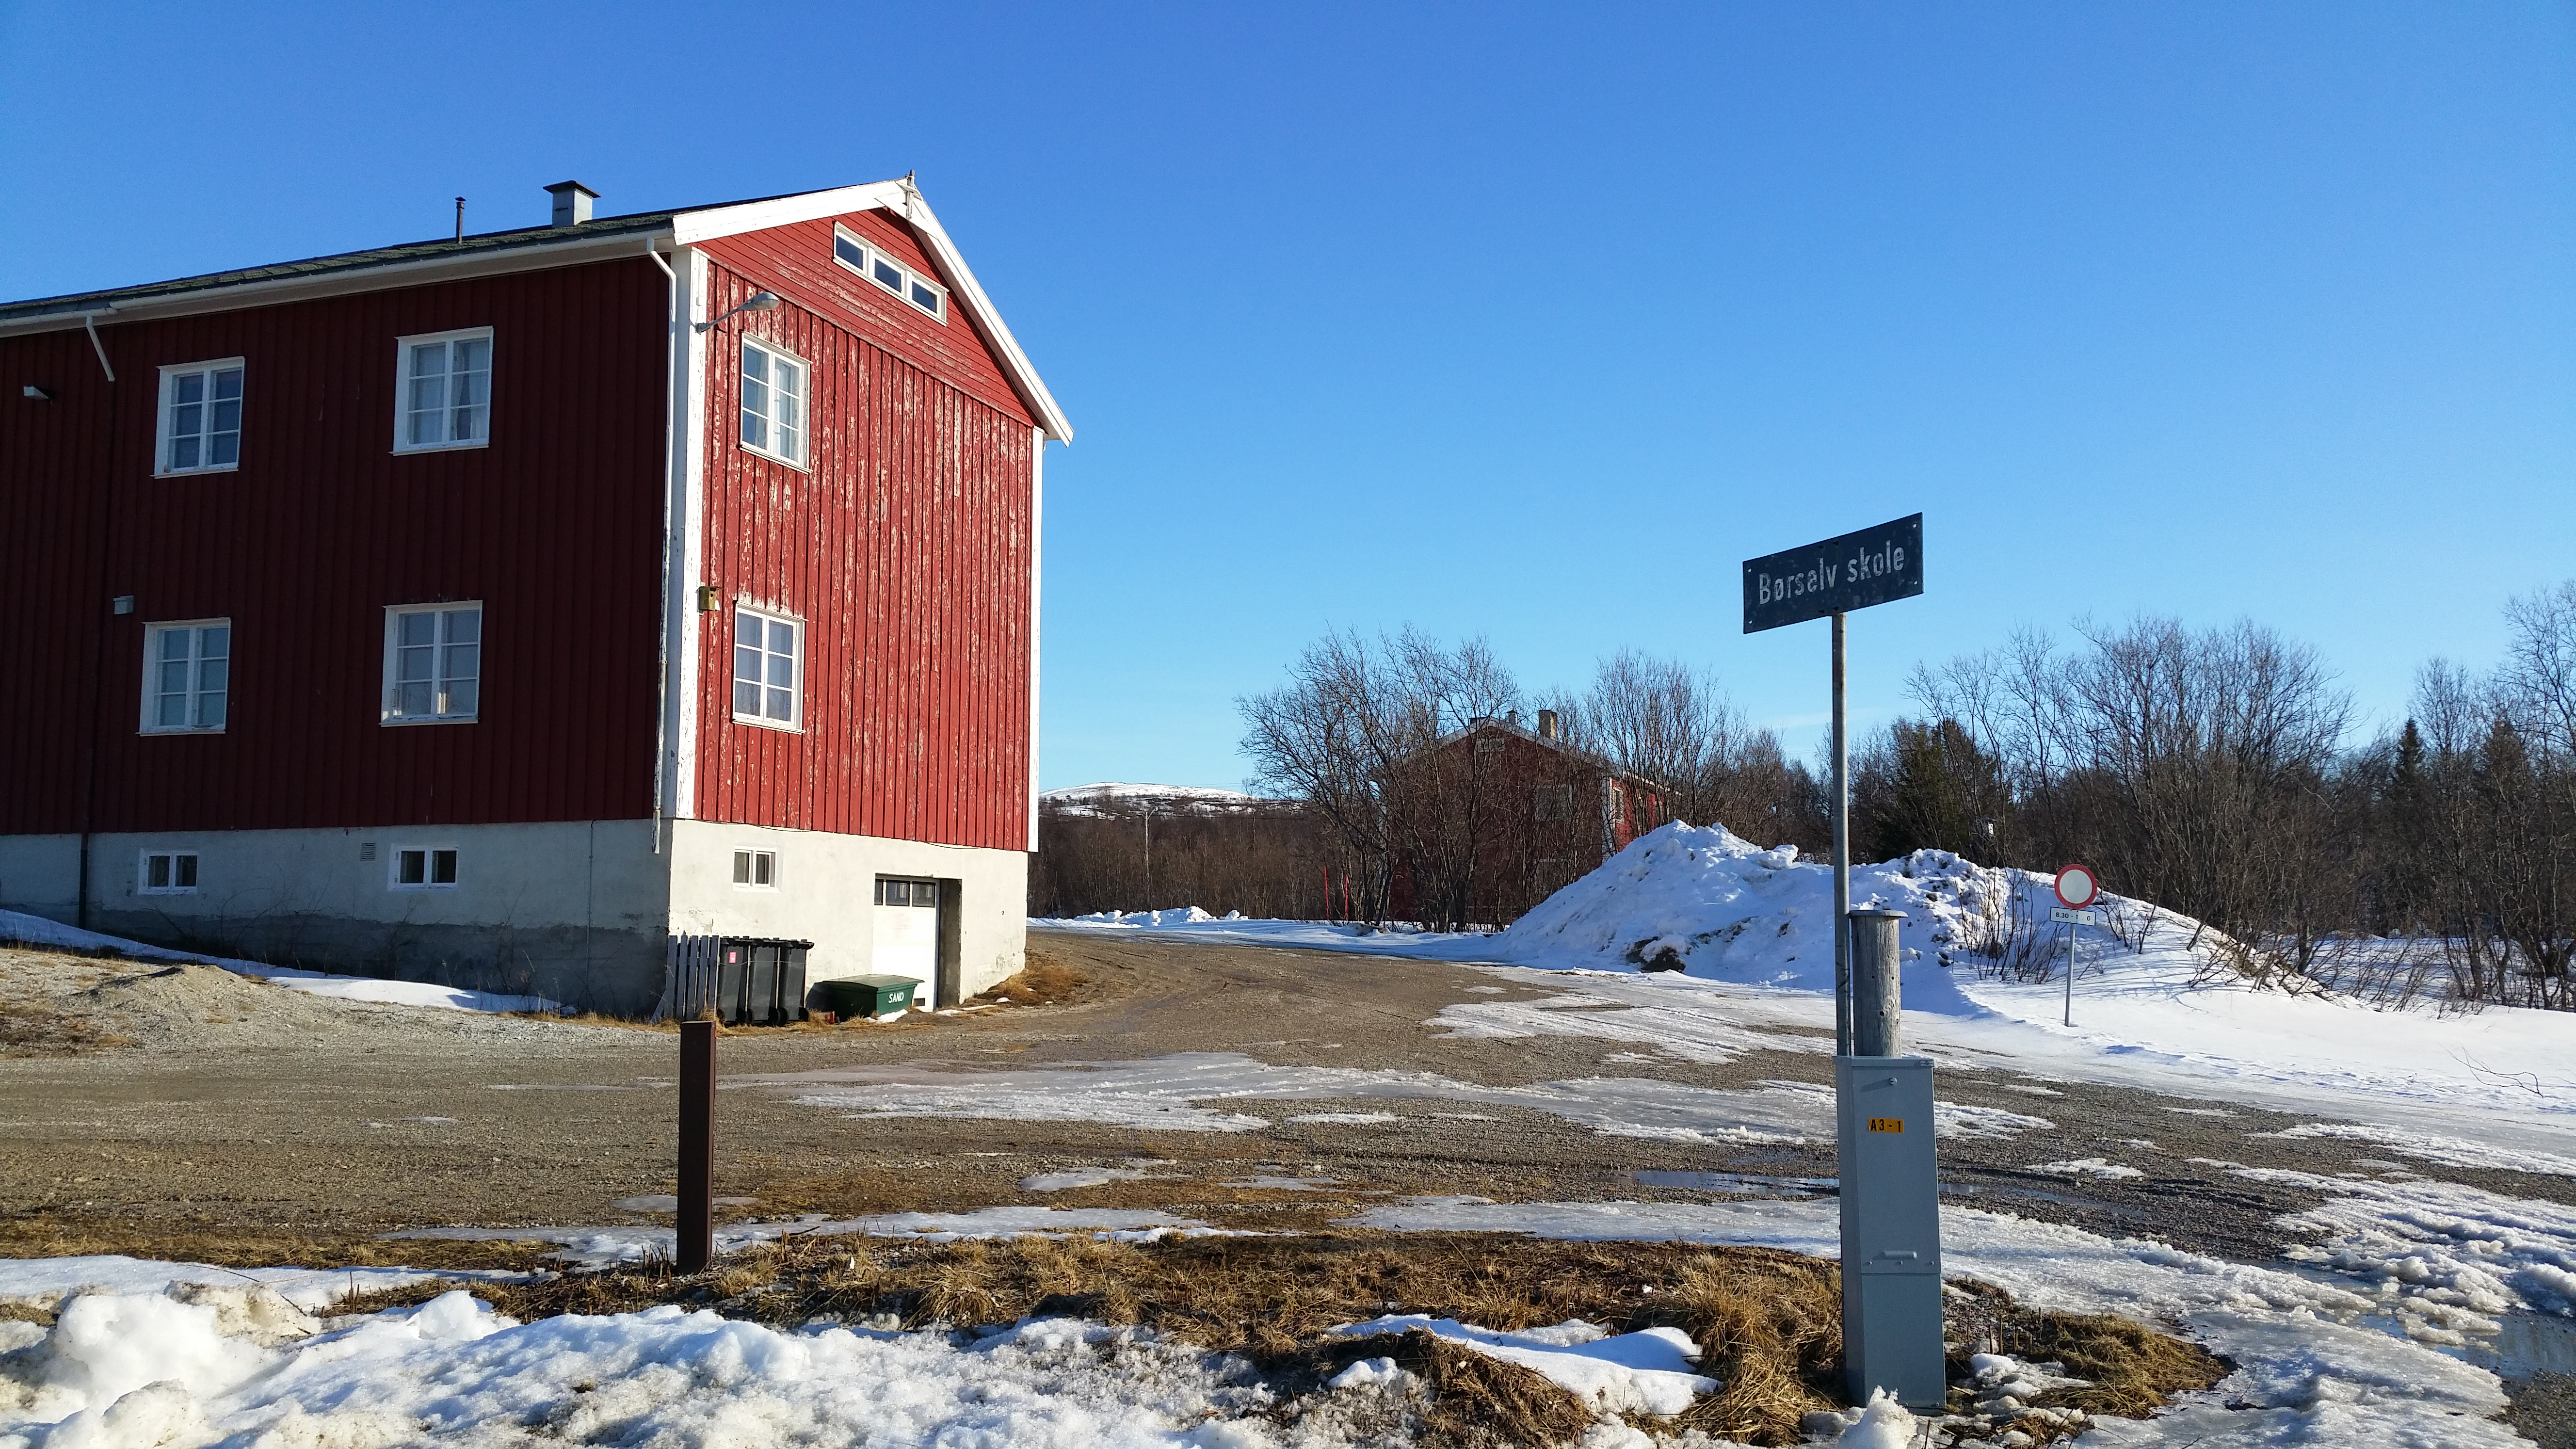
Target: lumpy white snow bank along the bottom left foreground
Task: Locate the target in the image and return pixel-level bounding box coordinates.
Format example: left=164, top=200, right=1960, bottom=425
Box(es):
left=0, top=1292, right=1275, bottom=1449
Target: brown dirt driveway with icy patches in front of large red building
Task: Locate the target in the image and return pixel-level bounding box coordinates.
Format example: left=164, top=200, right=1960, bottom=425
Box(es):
left=0, top=931, right=2576, bottom=1261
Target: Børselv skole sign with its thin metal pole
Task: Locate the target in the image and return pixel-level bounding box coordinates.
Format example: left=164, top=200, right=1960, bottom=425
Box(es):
left=1744, top=513, right=1924, bottom=1057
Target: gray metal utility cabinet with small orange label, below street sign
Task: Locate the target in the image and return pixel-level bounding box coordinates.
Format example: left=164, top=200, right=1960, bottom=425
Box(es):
left=1834, top=1057, right=1950, bottom=1408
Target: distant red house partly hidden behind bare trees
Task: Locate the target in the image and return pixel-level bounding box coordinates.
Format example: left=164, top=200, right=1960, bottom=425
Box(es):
left=1386, top=709, right=1669, bottom=926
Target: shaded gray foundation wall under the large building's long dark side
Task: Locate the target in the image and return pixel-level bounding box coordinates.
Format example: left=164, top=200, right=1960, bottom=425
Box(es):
left=0, top=820, right=670, bottom=1013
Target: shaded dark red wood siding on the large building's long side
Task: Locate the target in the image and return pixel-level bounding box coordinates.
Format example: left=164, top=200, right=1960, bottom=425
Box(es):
left=0, top=258, right=667, bottom=833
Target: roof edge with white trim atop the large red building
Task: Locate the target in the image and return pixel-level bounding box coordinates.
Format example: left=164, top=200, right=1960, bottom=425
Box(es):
left=0, top=178, right=1074, bottom=433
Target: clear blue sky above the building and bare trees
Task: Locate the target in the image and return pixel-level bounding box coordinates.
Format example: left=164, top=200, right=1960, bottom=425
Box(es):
left=0, top=0, right=2576, bottom=787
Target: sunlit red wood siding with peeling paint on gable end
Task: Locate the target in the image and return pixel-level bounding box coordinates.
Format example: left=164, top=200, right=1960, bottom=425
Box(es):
left=695, top=217, right=1035, bottom=851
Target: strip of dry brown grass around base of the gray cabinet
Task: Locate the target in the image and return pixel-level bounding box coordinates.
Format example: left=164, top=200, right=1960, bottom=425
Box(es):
left=376, top=1232, right=2226, bottom=1449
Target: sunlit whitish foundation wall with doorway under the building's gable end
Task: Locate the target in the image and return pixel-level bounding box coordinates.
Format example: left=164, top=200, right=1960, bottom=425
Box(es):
left=670, top=820, right=1028, bottom=1006
